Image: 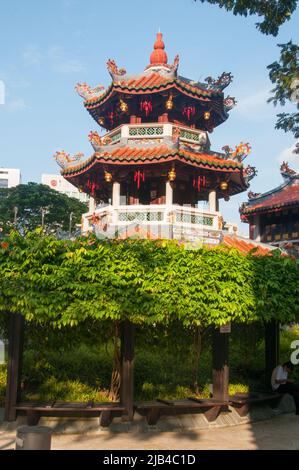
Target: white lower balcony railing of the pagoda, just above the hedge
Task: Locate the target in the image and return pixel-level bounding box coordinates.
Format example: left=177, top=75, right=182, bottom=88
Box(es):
left=83, top=204, right=222, bottom=243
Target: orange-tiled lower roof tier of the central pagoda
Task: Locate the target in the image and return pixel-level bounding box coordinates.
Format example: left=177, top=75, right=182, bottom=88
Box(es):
left=61, top=145, right=243, bottom=177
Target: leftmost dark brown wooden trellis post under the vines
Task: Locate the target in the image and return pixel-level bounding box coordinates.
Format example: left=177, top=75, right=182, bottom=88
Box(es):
left=4, top=313, right=24, bottom=421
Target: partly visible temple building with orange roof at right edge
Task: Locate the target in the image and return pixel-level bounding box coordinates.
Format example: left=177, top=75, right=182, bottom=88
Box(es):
left=240, top=162, right=299, bottom=254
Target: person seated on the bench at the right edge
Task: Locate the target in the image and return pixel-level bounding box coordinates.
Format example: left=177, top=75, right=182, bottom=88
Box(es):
left=271, top=361, right=299, bottom=415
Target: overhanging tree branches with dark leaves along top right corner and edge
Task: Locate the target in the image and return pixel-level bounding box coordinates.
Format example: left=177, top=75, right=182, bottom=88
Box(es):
left=195, top=0, right=299, bottom=149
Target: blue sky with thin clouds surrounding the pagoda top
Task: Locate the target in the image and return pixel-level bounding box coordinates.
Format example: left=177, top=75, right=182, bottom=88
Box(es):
left=0, top=0, right=299, bottom=233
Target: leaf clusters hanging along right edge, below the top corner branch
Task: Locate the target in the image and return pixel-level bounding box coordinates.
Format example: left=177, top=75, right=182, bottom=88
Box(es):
left=268, top=41, right=299, bottom=153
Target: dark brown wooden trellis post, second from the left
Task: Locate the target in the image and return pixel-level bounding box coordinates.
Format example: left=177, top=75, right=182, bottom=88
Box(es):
left=120, top=321, right=134, bottom=421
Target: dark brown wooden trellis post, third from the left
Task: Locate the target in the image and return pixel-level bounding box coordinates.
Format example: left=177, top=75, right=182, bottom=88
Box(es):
left=212, top=328, right=229, bottom=401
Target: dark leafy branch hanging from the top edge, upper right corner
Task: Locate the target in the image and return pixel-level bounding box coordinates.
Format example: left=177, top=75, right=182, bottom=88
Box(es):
left=195, top=0, right=298, bottom=36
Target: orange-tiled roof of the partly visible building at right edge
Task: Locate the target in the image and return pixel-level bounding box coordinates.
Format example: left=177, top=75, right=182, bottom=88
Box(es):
left=240, top=172, right=299, bottom=219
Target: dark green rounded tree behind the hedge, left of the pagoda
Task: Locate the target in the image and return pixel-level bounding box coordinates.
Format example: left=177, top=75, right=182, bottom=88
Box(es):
left=0, top=183, right=87, bottom=235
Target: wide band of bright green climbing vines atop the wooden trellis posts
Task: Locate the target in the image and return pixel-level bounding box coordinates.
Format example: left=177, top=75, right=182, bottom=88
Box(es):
left=0, top=232, right=299, bottom=328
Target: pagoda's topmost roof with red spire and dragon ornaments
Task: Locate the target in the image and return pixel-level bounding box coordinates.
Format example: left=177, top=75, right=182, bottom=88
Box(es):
left=75, top=33, right=236, bottom=130
